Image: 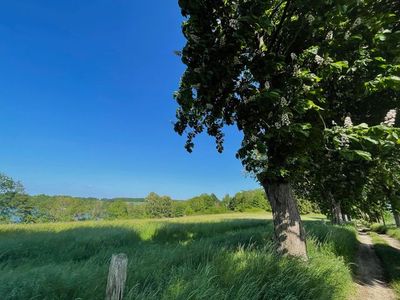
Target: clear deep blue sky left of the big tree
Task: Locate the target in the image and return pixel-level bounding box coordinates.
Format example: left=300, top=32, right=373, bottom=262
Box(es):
left=0, top=0, right=257, bottom=199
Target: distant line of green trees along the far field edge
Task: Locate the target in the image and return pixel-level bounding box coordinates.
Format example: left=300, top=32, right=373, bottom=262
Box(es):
left=0, top=174, right=319, bottom=223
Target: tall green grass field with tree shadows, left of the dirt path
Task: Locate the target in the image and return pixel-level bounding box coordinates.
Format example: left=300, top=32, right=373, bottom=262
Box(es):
left=0, top=213, right=357, bottom=300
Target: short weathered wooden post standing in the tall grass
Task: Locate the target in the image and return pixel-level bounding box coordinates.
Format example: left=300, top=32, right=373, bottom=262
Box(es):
left=106, top=253, right=128, bottom=300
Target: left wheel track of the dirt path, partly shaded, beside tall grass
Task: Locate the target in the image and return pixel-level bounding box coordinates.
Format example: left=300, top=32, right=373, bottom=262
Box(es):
left=353, top=232, right=396, bottom=300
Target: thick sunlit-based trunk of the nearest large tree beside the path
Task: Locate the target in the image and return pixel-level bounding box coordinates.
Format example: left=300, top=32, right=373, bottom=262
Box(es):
left=263, top=183, right=308, bottom=260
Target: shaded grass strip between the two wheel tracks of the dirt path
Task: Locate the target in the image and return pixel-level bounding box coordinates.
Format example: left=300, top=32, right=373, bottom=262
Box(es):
left=370, top=232, right=400, bottom=298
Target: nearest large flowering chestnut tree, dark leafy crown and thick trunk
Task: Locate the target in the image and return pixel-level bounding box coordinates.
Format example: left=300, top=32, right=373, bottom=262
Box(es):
left=175, top=0, right=398, bottom=259
